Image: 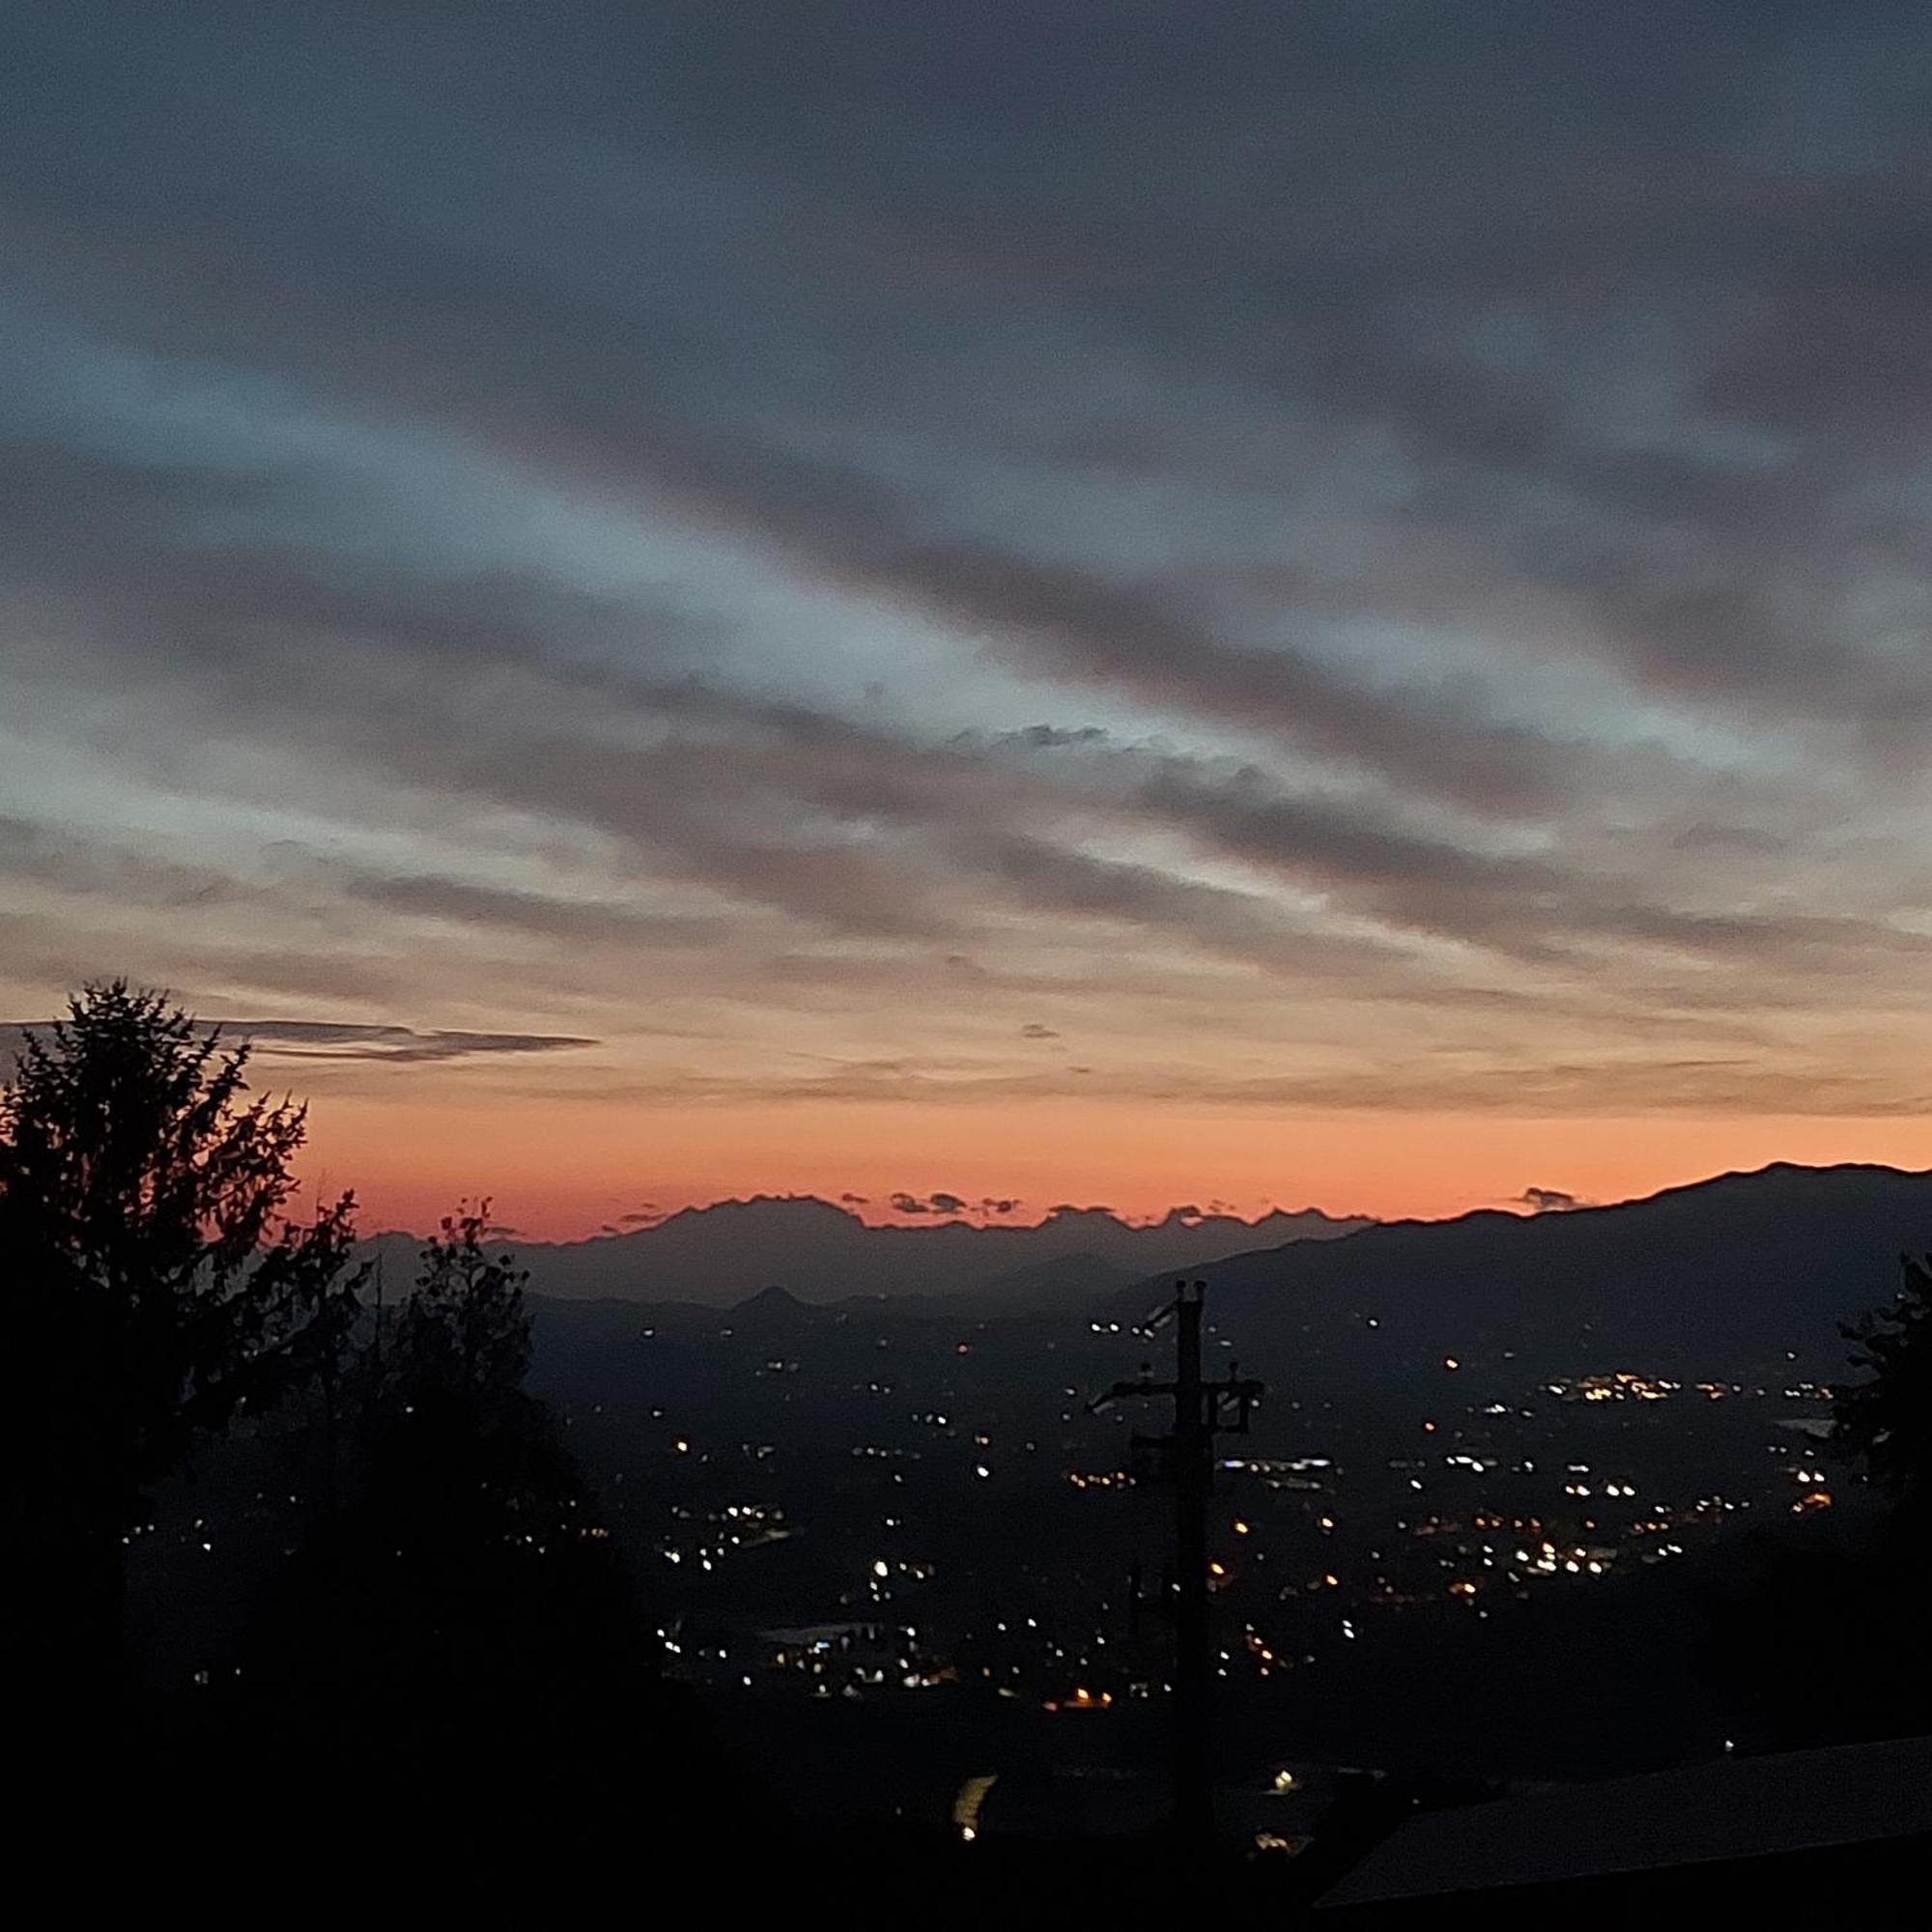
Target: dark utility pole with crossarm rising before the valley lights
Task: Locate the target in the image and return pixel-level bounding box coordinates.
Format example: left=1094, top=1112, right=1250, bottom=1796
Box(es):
left=1088, top=1281, right=1265, bottom=1859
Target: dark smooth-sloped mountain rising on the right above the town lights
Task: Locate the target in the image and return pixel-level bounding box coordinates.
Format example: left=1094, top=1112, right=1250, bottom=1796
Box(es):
left=1109, top=1163, right=1932, bottom=1401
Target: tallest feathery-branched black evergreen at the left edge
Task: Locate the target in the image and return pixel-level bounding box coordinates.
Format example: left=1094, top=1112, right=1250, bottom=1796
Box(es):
left=0, top=980, right=357, bottom=1716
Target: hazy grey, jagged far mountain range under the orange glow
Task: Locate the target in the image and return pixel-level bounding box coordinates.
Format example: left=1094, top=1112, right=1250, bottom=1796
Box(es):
left=359, top=1194, right=1372, bottom=1310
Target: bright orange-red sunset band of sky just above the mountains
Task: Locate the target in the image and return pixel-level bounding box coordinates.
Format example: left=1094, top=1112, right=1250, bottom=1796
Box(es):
left=290, top=1095, right=1932, bottom=1240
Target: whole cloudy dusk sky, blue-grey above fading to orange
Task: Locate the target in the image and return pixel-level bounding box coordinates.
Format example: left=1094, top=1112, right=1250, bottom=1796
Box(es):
left=0, top=0, right=1932, bottom=1235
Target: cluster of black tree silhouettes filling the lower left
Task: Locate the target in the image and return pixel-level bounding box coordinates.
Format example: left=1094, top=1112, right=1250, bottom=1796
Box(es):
left=0, top=983, right=755, bottom=1897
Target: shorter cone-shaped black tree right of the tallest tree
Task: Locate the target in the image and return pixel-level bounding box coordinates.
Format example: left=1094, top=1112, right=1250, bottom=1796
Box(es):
left=214, top=1204, right=744, bottom=1903
